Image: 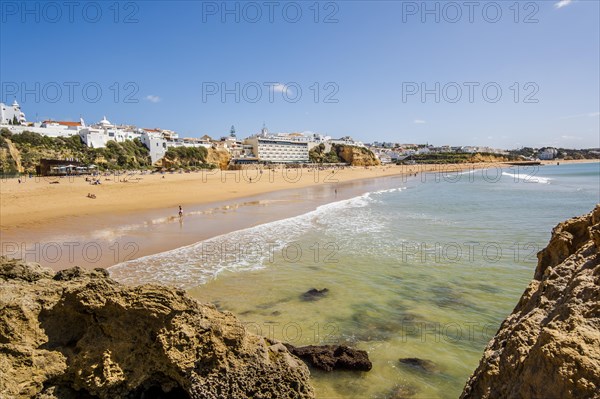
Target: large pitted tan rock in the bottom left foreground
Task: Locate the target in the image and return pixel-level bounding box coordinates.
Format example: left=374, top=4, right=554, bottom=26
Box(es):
left=0, top=258, right=314, bottom=399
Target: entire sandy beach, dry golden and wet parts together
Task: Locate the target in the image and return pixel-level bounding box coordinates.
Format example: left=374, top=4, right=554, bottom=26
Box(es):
left=2, top=162, right=596, bottom=270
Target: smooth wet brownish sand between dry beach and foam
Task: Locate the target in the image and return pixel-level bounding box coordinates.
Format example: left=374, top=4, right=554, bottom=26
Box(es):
left=2, top=170, right=428, bottom=270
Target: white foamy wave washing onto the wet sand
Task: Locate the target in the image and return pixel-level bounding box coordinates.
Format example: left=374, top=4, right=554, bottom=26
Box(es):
left=108, top=187, right=404, bottom=289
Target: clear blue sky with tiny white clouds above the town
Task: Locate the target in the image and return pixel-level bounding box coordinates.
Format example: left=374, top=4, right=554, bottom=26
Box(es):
left=0, top=0, right=600, bottom=148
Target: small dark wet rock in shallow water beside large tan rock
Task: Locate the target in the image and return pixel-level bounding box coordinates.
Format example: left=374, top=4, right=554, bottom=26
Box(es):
left=285, top=344, right=373, bottom=371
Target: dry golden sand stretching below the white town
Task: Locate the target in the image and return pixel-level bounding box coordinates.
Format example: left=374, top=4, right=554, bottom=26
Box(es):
left=0, top=164, right=493, bottom=230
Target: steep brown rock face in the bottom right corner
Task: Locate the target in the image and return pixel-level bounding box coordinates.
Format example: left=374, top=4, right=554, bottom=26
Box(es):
left=461, top=205, right=600, bottom=399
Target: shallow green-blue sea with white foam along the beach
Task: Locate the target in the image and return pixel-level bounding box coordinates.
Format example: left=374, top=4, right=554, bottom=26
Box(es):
left=109, top=163, right=600, bottom=399
